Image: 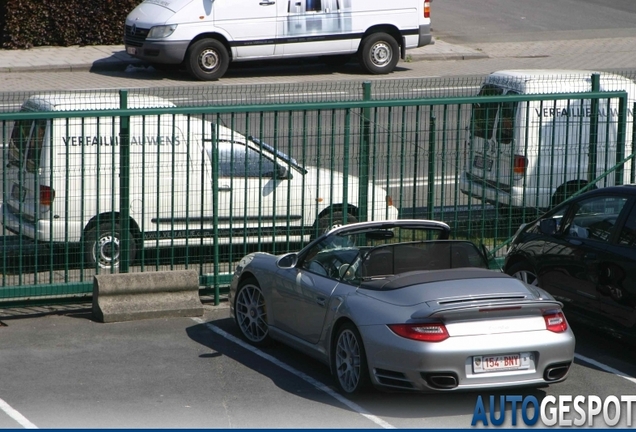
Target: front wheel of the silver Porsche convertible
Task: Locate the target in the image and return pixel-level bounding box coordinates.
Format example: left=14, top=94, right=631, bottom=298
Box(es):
left=234, top=278, right=271, bottom=347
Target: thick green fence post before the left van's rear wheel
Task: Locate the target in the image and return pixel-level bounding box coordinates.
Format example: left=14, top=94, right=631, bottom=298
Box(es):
left=119, top=90, right=131, bottom=273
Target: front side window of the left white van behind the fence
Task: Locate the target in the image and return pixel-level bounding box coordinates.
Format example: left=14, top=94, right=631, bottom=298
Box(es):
left=219, top=142, right=275, bottom=177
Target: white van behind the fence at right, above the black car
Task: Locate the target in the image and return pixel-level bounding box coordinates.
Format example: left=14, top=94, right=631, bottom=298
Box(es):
left=461, top=70, right=636, bottom=211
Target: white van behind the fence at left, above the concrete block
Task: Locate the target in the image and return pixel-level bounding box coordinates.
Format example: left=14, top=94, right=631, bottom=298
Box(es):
left=0, top=94, right=398, bottom=268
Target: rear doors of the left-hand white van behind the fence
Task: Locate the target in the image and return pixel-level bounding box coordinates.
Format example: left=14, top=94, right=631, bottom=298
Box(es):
left=3, top=120, right=50, bottom=238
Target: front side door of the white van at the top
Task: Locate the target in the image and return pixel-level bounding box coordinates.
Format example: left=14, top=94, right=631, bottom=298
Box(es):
left=214, top=0, right=277, bottom=59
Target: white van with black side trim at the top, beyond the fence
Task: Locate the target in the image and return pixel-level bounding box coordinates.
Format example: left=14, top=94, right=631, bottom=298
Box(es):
left=124, top=0, right=432, bottom=80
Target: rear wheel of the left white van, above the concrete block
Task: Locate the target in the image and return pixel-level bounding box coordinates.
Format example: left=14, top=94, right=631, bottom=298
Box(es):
left=84, top=223, right=137, bottom=269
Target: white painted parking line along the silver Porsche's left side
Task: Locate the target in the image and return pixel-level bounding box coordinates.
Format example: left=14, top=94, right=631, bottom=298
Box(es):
left=192, top=318, right=395, bottom=429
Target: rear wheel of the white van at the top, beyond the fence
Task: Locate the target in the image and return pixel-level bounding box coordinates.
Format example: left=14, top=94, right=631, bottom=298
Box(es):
left=358, top=33, right=400, bottom=75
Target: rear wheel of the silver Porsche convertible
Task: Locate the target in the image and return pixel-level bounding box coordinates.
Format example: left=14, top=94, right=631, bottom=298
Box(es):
left=331, top=322, right=370, bottom=395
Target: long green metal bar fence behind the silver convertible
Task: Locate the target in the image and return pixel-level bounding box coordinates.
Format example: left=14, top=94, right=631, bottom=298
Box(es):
left=0, top=78, right=636, bottom=306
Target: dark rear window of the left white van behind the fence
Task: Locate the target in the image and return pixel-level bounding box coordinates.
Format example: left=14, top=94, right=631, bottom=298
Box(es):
left=8, top=120, right=46, bottom=172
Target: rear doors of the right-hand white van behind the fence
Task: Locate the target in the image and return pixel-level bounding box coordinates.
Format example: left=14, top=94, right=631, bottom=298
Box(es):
left=466, top=84, right=525, bottom=204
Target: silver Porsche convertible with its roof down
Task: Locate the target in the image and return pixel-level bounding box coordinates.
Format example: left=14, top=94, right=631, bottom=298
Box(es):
left=230, top=220, right=575, bottom=394
